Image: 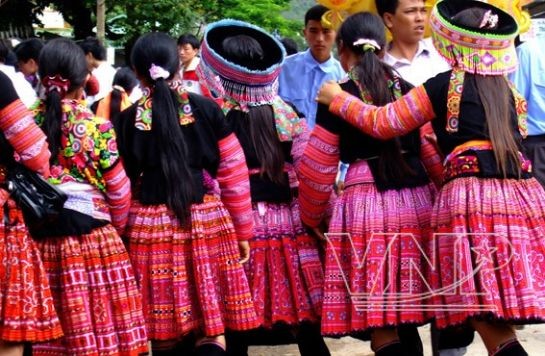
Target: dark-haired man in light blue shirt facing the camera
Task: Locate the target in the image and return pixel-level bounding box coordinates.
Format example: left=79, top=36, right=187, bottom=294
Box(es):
left=278, top=5, right=345, bottom=128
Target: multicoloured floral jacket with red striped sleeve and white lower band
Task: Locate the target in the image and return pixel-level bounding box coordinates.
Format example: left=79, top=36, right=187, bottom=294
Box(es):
left=34, top=99, right=131, bottom=233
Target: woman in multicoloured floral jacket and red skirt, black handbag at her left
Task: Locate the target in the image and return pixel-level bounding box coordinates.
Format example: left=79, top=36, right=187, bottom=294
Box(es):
left=32, top=39, right=148, bottom=356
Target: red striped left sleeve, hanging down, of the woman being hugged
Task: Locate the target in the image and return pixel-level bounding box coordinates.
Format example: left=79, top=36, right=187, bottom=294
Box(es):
left=298, top=125, right=340, bottom=227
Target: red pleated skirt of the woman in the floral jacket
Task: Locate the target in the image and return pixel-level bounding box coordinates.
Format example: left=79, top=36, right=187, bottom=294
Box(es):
left=32, top=224, right=148, bottom=356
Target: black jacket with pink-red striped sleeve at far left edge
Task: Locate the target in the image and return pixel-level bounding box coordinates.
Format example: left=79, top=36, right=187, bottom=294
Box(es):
left=0, top=72, right=51, bottom=204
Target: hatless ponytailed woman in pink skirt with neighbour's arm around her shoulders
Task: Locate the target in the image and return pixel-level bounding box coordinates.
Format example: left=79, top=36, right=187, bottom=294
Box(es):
left=299, top=13, right=440, bottom=355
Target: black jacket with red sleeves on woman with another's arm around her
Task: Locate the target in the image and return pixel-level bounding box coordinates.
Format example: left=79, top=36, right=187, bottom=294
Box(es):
left=298, top=79, right=440, bottom=227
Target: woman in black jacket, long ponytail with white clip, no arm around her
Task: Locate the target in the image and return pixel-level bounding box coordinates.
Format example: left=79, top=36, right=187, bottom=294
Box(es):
left=113, top=33, right=257, bottom=355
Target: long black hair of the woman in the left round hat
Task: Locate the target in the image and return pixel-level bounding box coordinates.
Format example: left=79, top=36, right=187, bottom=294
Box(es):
left=222, top=35, right=284, bottom=184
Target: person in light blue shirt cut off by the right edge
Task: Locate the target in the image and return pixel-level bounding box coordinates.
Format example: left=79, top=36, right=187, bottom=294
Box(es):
left=510, top=36, right=545, bottom=187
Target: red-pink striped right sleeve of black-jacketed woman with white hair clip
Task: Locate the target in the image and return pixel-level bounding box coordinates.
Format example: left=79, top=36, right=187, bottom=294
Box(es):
left=216, top=133, right=254, bottom=240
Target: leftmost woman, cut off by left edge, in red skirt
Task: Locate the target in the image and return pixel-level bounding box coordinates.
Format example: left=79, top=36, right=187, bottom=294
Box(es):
left=0, top=72, right=62, bottom=356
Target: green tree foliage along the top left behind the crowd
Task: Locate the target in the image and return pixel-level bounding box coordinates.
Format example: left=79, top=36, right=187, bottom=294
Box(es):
left=0, top=0, right=315, bottom=45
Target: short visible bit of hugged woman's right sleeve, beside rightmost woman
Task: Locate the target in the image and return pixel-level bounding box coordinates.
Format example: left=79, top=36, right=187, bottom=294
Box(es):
left=420, top=122, right=443, bottom=186
